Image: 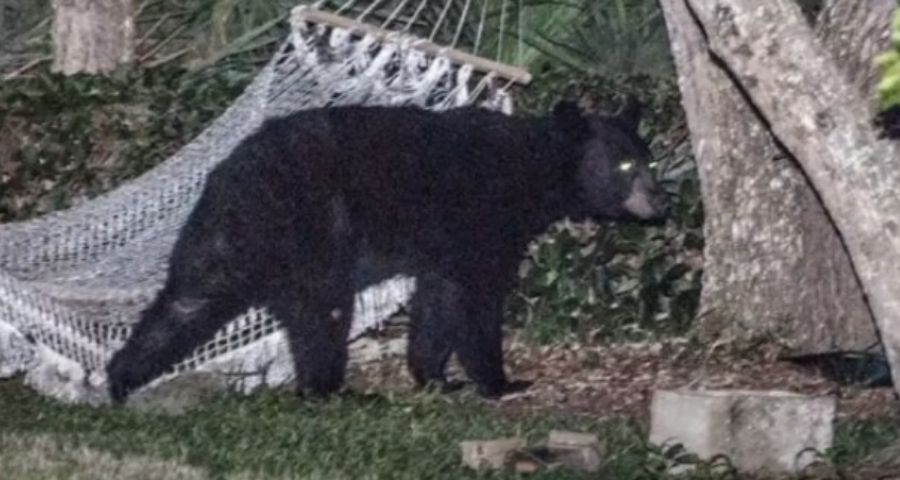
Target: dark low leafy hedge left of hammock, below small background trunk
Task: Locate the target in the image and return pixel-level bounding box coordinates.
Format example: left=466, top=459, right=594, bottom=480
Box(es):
left=0, top=65, right=255, bottom=221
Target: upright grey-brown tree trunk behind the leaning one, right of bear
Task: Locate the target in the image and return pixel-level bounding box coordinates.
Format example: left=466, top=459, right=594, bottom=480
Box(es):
left=660, top=0, right=877, bottom=353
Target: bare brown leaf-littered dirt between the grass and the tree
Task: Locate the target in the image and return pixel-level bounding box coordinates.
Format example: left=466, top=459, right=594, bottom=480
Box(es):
left=348, top=334, right=900, bottom=422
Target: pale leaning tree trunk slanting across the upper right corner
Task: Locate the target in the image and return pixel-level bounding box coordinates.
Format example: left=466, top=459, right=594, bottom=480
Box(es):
left=687, top=0, right=900, bottom=388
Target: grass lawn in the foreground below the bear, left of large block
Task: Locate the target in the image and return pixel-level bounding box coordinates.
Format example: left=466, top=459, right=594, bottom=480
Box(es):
left=0, top=381, right=752, bottom=480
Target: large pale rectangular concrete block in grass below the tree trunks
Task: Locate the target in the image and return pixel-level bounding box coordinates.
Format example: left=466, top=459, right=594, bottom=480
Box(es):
left=650, top=390, right=835, bottom=473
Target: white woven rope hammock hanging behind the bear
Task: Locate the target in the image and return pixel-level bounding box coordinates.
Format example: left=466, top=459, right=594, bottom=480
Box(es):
left=0, top=0, right=529, bottom=402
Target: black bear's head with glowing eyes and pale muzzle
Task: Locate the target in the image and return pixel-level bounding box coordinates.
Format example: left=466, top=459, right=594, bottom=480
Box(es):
left=553, top=99, right=669, bottom=225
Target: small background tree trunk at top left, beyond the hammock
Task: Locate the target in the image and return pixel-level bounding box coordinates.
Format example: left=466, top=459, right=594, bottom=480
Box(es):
left=53, top=0, right=134, bottom=75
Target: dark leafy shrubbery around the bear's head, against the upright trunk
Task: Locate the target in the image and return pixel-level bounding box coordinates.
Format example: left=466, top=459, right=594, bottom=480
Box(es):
left=508, top=67, right=703, bottom=343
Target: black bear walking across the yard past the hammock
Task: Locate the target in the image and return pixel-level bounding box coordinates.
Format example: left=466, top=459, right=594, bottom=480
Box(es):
left=107, top=98, right=668, bottom=401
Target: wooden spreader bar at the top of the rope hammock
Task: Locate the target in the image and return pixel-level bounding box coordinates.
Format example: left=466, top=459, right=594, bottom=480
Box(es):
left=298, top=8, right=531, bottom=85
